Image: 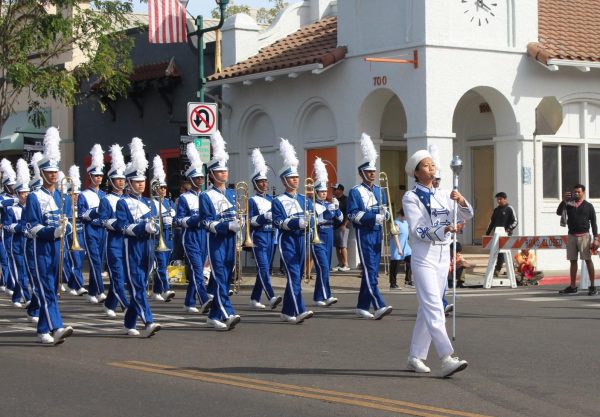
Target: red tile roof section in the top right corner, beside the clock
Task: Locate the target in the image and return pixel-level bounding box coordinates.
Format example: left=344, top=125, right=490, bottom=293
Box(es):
left=527, top=0, right=600, bottom=64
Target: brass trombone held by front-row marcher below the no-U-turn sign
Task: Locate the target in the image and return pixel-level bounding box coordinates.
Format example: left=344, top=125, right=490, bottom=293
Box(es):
left=233, top=181, right=254, bottom=294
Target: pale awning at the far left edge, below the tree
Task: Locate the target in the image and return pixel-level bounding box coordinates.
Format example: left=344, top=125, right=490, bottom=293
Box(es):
left=0, top=109, right=51, bottom=153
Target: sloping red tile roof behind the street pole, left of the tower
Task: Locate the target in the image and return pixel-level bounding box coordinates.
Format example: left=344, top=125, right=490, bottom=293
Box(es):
left=208, top=16, right=347, bottom=81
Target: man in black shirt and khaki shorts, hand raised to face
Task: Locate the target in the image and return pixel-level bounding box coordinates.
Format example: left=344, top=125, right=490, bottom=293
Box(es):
left=556, top=184, right=600, bottom=295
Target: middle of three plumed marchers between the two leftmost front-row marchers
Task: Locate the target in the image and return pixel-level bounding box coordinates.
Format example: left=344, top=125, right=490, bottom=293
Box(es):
left=77, top=144, right=106, bottom=304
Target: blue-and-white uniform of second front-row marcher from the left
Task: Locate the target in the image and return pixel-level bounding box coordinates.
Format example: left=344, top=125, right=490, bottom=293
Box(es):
left=113, top=195, right=156, bottom=329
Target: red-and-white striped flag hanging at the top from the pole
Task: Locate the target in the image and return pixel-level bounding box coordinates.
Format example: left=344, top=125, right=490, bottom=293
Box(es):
left=148, top=0, right=187, bottom=43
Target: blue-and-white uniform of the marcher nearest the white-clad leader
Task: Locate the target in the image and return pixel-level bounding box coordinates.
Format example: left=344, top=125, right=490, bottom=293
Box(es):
left=346, top=182, right=389, bottom=311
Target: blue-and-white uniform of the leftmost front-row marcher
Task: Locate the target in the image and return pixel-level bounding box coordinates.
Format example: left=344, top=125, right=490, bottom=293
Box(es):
left=25, top=188, right=71, bottom=334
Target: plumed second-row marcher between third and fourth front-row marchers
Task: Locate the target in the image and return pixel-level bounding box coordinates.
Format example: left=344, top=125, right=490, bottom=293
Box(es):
left=248, top=148, right=283, bottom=310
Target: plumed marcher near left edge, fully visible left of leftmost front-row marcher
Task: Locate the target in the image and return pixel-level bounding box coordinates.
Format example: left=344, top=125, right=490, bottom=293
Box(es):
left=3, top=158, right=31, bottom=307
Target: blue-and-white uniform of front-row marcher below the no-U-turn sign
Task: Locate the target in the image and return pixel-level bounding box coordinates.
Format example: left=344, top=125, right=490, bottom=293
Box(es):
left=200, top=187, right=236, bottom=321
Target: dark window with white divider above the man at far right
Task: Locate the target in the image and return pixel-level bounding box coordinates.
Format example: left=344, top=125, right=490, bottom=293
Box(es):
left=542, top=145, right=580, bottom=198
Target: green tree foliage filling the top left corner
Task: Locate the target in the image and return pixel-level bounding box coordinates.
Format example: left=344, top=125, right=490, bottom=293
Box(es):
left=0, top=0, right=133, bottom=127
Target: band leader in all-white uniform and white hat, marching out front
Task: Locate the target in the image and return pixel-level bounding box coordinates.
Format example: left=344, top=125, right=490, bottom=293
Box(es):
left=402, top=150, right=473, bottom=377
